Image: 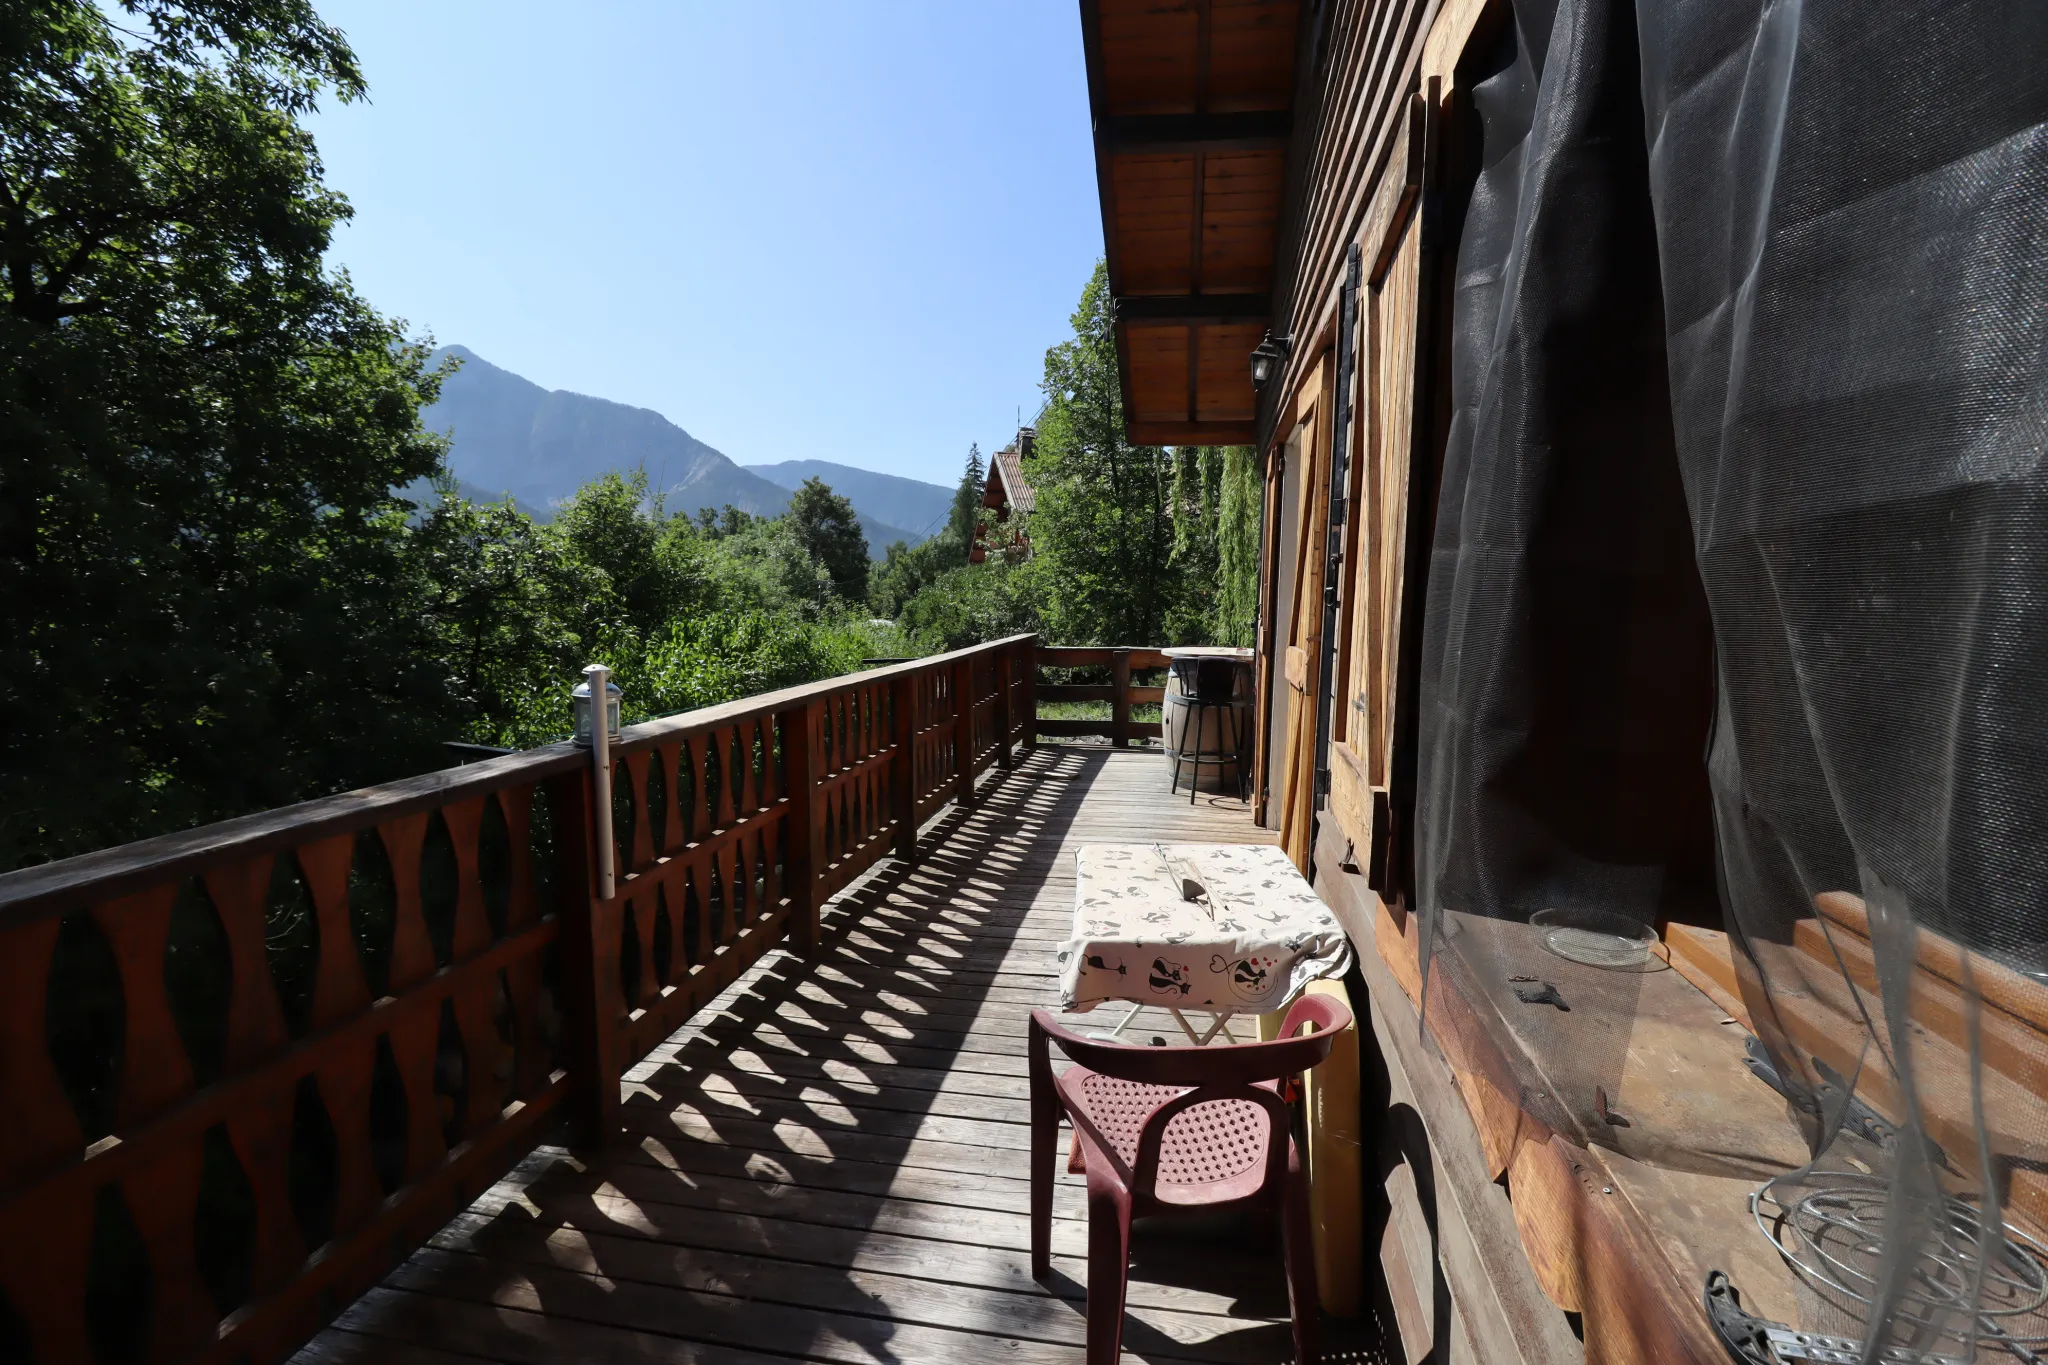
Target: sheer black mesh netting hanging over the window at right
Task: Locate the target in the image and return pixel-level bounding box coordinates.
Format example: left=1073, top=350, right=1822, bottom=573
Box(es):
left=1415, top=0, right=2048, bottom=1355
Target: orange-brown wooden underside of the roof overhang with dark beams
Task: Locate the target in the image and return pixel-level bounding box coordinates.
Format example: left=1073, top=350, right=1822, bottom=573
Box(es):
left=1081, top=0, right=1300, bottom=446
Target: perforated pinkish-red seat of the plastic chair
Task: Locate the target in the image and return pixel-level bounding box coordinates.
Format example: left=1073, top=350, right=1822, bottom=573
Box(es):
left=1059, top=1066, right=1274, bottom=1203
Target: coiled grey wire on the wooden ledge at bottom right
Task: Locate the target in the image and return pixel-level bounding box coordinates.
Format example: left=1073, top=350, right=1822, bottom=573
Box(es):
left=1749, top=1173, right=2048, bottom=1361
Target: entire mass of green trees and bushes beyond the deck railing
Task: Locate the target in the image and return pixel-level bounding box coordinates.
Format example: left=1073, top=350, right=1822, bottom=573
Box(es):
left=0, top=0, right=1260, bottom=868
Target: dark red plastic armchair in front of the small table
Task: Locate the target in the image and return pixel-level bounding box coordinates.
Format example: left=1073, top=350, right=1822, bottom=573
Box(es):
left=1030, top=995, right=1352, bottom=1365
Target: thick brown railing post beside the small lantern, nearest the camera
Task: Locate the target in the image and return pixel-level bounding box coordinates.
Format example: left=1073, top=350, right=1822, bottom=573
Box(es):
left=547, top=767, right=621, bottom=1152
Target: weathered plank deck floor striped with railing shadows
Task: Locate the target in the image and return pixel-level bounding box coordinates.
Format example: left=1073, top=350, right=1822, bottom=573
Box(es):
left=299, top=747, right=1372, bottom=1365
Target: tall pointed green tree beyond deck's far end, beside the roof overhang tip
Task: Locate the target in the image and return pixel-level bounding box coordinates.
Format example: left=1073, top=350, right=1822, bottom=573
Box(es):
left=1026, top=262, right=1186, bottom=645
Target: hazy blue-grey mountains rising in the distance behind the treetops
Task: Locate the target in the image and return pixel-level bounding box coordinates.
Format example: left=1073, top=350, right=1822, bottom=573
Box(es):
left=422, top=346, right=922, bottom=559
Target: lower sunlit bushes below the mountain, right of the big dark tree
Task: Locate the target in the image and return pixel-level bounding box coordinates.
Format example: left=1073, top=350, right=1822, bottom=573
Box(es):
left=416, top=473, right=895, bottom=747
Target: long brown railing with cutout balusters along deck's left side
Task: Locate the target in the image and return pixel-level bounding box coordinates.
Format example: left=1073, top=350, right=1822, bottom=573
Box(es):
left=0, top=636, right=1032, bottom=1365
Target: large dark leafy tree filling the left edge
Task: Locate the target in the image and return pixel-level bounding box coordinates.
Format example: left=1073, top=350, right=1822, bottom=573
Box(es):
left=0, top=0, right=455, bottom=866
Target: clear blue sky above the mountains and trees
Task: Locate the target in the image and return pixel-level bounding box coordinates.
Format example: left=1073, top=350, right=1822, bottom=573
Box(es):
left=311, top=0, right=1102, bottom=483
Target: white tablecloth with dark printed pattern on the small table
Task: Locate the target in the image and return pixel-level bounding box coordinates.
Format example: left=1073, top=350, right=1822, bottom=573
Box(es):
left=1059, top=843, right=1352, bottom=1013
